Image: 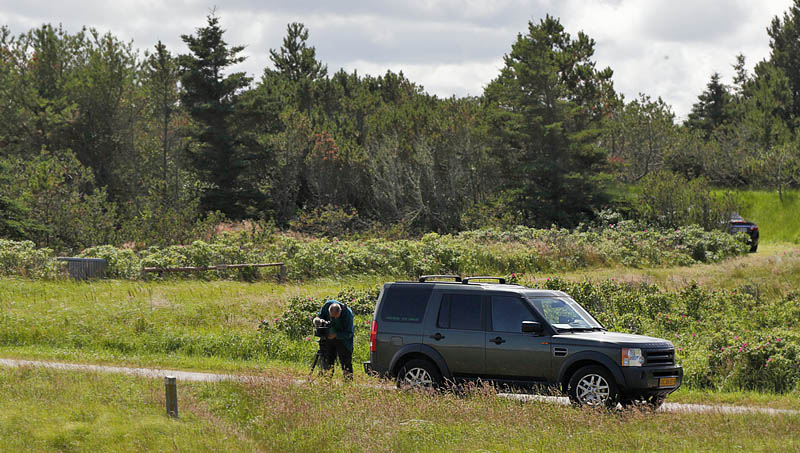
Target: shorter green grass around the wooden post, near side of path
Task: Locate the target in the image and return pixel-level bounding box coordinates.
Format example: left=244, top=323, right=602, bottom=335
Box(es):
left=0, top=368, right=257, bottom=452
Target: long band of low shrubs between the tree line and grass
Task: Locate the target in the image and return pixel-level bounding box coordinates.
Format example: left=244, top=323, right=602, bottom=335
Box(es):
left=3, top=221, right=747, bottom=280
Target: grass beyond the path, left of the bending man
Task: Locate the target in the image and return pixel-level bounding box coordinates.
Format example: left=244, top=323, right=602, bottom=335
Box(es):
left=0, top=279, right=377, bottom=368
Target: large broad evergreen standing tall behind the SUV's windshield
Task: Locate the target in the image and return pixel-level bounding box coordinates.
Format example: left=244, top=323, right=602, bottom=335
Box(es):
left=486, top=16, right=613, bottom=226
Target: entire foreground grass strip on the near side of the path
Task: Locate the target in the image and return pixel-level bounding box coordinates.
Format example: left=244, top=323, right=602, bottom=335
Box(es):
left=0, top=368, right=800, bottom=452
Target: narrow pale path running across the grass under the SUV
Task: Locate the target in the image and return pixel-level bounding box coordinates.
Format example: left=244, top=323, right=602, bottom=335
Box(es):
left=0, top=359, right=800, bottom=415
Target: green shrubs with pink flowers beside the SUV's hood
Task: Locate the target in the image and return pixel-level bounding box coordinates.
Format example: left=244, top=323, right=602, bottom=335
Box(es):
left=542, top=278, right=800, bottom=392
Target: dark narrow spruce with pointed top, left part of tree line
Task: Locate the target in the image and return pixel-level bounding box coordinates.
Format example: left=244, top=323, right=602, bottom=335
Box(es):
left=178, top=12, right=260, bottom=218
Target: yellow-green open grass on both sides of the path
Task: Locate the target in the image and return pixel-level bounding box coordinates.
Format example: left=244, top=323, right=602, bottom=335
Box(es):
left=0, top=219, right=800, bottom=451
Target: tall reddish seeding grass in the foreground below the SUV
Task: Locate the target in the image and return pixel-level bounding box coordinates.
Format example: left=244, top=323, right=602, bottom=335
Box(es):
left=198, top=370, right=800, bottom=452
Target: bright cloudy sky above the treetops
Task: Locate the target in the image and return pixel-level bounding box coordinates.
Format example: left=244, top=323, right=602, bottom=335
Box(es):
left=0, top=0, right=793, bottom=119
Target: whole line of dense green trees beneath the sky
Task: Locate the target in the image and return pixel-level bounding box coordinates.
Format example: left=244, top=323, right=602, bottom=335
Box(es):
left=0, top=0, right=800, bottom=249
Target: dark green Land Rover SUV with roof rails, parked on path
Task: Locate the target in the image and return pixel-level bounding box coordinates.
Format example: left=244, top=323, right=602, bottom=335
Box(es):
left=364, top=275, right=683, bottom=407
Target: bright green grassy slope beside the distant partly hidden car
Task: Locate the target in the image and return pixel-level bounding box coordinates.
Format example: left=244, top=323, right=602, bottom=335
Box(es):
left=736, top=190, right=800, bottom=244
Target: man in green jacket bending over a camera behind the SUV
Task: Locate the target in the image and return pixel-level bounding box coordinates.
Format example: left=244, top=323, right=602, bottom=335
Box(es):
left=319, top=299, right=353, bottom=379
